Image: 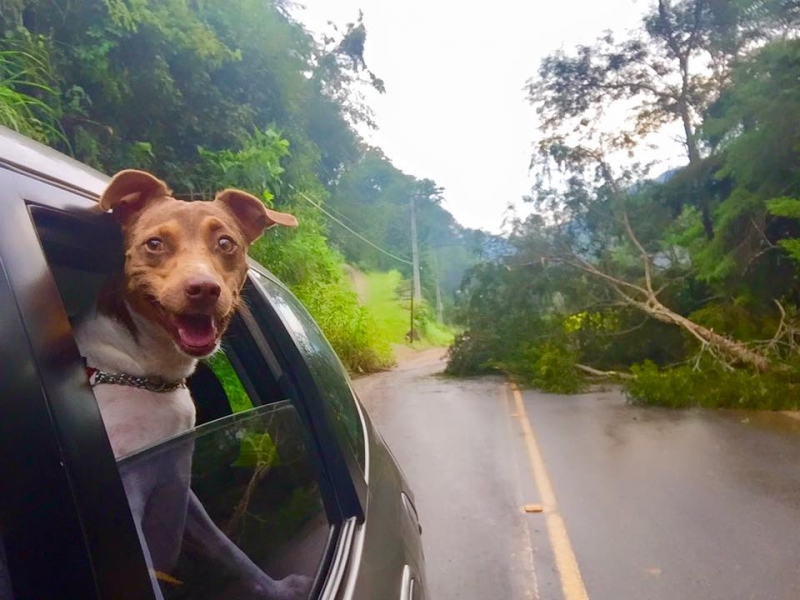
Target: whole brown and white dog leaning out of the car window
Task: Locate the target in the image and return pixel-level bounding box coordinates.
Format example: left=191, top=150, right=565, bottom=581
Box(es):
left=75, top=170, right=309, bottom=600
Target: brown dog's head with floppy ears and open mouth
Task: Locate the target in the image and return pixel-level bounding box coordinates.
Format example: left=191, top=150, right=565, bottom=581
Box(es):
left=100, top=170, right=297, bottom=358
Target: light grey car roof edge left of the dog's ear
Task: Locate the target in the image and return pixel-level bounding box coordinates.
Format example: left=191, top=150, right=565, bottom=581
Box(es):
left=0, top=126, right=109, bottom=197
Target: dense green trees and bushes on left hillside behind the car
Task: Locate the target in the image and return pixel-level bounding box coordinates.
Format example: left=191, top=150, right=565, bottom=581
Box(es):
left=0, top=0, right=468, bottom=371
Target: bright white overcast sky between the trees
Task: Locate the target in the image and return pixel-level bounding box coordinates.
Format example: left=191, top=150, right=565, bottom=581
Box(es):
left=295, top=0, right=684, bottom=232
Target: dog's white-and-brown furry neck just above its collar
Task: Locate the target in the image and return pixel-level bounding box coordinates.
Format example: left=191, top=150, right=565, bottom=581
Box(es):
left=75, top=301, right=197, bottom=381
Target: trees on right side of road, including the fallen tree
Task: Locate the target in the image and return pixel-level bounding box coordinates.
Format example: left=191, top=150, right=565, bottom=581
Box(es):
left=449, top=0, right=800, bottom=409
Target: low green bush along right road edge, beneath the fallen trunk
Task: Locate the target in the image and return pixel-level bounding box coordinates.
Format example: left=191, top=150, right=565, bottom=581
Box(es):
left=625, top=360, right=800, bottom=410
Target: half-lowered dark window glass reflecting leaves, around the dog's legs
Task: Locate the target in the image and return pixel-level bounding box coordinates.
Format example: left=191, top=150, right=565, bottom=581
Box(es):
left=120, top=401, right=329, bottom=600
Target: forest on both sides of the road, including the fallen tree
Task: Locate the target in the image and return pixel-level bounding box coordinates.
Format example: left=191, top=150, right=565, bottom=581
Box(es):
left=0, top=0, right=800, bottom=409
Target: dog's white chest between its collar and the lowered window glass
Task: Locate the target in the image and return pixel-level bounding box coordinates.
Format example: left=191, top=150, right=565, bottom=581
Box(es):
left=94, top=384, right=195, bottom=458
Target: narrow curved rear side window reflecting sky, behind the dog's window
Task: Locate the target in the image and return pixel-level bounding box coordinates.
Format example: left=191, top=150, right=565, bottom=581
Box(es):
left=255, top=273, right=365, bottom=471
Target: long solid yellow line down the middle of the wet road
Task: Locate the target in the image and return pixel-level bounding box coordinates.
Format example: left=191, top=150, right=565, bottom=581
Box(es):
left=511, top=386, right=589, bottom=600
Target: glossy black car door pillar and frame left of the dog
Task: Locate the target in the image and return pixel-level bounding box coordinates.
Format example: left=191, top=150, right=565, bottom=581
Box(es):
left=0, top=168, right=155, bottom=600
